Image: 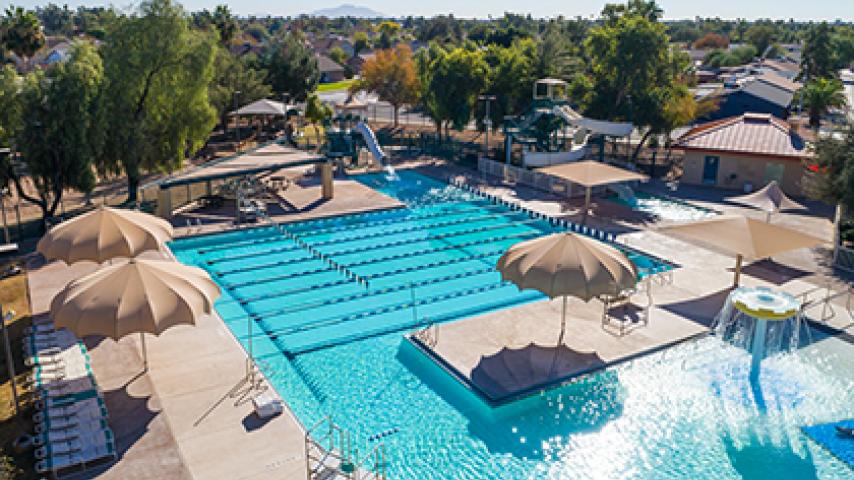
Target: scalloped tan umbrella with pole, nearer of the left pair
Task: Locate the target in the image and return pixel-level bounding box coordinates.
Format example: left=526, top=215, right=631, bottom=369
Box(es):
left=50, top=259, right=220, bottom=369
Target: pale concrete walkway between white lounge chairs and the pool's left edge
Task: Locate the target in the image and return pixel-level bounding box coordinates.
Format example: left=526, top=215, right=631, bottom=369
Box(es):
left=29, top=256, right=312, bottom=480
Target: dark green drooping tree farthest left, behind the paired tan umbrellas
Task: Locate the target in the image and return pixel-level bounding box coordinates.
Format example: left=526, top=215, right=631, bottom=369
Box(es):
left=6, top=42, right=103, bottom=228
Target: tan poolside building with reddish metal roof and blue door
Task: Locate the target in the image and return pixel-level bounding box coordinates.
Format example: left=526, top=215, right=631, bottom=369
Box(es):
left=676, top=113, right=810, bottom=195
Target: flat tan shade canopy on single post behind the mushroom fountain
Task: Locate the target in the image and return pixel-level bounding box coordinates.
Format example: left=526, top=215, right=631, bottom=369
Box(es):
left=661, top=215, right=825, bottom=287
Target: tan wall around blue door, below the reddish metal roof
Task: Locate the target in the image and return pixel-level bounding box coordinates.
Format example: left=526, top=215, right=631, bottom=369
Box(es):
left=682, top=151, right=804, bottom=196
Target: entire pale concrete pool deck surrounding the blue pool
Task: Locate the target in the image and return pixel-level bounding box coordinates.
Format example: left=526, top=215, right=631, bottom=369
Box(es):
left=28, top=162, right=854, bottom=480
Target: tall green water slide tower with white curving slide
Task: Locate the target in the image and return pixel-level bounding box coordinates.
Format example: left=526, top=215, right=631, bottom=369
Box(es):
left=503, top=78, right=633, bottom=167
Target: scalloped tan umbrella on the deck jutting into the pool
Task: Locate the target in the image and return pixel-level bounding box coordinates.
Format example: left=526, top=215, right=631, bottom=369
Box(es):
left=496, top=233, right=638, bottom=344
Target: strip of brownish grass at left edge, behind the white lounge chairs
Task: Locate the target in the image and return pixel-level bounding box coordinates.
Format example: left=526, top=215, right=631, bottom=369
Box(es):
left=0, top=265, right=40, bottom=480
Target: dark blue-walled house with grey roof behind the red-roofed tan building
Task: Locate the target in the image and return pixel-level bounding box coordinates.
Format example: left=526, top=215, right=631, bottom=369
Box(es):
left=705, top=73, right=800, bottom=120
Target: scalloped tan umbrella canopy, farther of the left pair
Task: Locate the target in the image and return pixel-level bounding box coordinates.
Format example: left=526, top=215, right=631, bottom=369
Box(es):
left=37, top=206, right=173, bottom=264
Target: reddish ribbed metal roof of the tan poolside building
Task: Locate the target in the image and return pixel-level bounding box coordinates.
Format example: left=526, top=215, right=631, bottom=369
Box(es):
left=677, top=113, right=809, bottom=158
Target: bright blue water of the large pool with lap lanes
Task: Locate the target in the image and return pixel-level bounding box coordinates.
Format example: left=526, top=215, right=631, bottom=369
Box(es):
left=171, top=172, right=854, bottom=480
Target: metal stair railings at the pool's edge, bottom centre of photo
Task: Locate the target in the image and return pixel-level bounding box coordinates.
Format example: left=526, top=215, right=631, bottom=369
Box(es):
left=305, top=417, right=388, bottom=480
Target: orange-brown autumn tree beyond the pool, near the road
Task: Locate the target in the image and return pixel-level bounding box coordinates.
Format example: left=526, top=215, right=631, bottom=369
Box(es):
left=350, top=44, right=419, bottom=127
